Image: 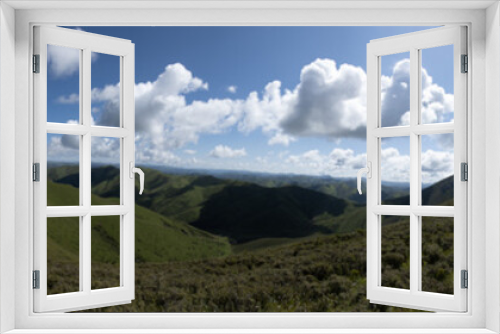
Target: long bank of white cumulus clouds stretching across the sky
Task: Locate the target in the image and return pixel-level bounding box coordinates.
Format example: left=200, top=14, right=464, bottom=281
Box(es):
left=59, top=59, right=453, bottom=170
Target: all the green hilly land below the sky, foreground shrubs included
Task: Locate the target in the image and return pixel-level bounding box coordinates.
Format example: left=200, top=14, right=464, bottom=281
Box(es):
left=48, top=167, right=453, bottom=312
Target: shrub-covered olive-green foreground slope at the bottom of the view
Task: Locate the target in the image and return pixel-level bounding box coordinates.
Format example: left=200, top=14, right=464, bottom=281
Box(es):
left=84, top=220, right=453, bottom=312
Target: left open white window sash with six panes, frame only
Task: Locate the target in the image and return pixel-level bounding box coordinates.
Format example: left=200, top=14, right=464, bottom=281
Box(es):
left=33, top=26, right=135, bottom=312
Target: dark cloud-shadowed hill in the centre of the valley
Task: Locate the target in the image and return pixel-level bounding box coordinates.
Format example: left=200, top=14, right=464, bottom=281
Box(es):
left=192, top=184, right=348, bottom=243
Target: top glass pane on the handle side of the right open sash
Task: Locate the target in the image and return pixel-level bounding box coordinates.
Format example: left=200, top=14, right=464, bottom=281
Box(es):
left=380, top=52, right=410, bottom=127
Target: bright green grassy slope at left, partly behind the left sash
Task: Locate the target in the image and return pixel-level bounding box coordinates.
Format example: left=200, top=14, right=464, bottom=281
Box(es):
left=47, top=181, right=231, bottom=293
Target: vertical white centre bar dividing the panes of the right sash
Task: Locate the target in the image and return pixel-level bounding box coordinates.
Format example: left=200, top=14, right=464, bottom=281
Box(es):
left=410, top=48, right=420, bottom=293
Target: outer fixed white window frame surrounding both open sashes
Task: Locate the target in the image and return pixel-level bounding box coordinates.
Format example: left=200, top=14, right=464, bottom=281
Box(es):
left=0, top=1, right=500, bottom=333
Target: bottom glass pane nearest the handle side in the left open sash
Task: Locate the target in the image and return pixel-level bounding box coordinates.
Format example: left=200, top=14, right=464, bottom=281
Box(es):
left=91, top=216, right=121, bottom=289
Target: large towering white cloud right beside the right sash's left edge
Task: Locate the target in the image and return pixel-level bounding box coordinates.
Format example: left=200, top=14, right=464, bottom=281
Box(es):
left=280, top=59, right=366, bottom=138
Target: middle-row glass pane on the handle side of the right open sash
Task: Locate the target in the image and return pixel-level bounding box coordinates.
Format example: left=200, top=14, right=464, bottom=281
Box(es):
left=380, top=137, right=410, bottom=205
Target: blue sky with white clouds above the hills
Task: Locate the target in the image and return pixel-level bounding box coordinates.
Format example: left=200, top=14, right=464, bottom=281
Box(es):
left=48, top=27, right=453, bottom=181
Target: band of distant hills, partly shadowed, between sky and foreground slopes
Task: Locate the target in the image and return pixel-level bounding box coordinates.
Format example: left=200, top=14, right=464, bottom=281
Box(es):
left=49, top=166, right=453, bottom=245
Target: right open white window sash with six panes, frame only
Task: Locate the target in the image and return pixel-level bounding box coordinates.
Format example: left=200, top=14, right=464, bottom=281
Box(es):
left=366, top=26, right=469, bottom=312
